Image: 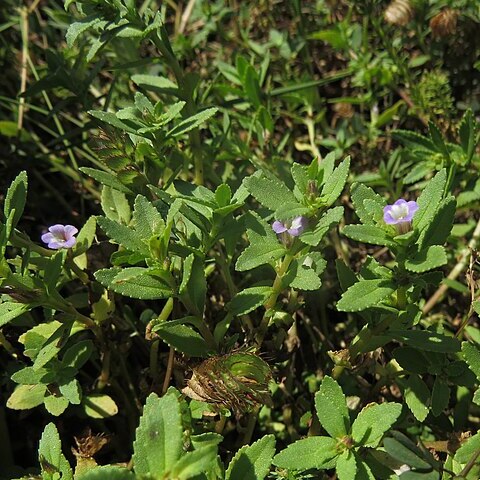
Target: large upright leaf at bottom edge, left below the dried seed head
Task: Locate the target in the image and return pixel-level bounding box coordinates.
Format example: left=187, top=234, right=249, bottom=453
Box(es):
left=133, top=390, right=183, bottom=478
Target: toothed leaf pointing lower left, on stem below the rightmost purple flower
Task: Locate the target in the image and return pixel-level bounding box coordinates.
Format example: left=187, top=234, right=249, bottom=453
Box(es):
left=337, top=279, right=395, bottom=312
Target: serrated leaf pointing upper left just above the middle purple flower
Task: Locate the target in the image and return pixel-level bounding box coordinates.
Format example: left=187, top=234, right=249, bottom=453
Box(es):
left=243, top=172, right=298, bottom=211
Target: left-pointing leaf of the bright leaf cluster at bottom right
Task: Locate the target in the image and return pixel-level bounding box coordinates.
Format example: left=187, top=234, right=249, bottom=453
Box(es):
left=273, top=437, right=339, bottom=470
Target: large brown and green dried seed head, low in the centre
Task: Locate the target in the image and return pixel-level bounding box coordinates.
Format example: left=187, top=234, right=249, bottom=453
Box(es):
left=183, top=351, right=272, bottom=415
